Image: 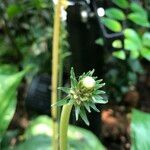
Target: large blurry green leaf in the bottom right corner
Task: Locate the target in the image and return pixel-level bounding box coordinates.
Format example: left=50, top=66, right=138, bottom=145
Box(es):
left=131, top=109, right=150, bottom=150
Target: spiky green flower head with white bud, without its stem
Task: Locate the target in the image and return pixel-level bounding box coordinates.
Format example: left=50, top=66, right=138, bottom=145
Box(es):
left=55, top=68, right=107, bottom=125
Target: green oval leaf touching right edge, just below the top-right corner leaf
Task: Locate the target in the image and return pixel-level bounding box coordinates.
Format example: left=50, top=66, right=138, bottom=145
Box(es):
left=128, top=13, right=150, bottom=27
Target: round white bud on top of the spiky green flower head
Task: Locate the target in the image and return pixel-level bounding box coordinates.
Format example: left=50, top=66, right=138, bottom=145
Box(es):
left=82, top=76, right=96, bottom=90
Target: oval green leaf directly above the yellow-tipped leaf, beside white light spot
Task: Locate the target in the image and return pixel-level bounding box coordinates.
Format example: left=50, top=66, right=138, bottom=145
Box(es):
left=106, top=8, right=126, bottom=20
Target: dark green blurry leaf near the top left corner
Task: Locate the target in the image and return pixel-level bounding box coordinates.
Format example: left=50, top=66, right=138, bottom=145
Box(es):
left=6, top=4, right=23, bottom=19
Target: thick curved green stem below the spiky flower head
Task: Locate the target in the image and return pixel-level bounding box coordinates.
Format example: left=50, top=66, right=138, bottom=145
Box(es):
left=59, top=104, right=73, bottom=150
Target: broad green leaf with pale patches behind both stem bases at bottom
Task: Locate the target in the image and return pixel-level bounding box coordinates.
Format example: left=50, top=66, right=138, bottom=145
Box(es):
left=6, top=116, right=105, bottom=150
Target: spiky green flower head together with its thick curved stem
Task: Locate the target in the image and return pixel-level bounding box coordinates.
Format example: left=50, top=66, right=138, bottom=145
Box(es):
left=54, top=68, right=108, bottom=150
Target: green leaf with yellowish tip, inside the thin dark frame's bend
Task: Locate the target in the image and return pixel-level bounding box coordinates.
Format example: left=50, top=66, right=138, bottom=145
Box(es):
left=101, top=17, right=122, bottom=32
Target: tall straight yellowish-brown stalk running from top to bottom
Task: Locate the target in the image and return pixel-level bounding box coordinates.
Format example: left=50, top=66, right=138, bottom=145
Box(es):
left=51, top=0, right=61, bottom=150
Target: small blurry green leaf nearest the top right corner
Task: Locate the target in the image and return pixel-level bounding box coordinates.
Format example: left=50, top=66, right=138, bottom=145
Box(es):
left=130, top=2, right=147, bottom=16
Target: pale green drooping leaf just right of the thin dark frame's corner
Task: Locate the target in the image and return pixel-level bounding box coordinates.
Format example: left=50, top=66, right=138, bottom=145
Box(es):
left=124, top=28, right=142, bottom=49
